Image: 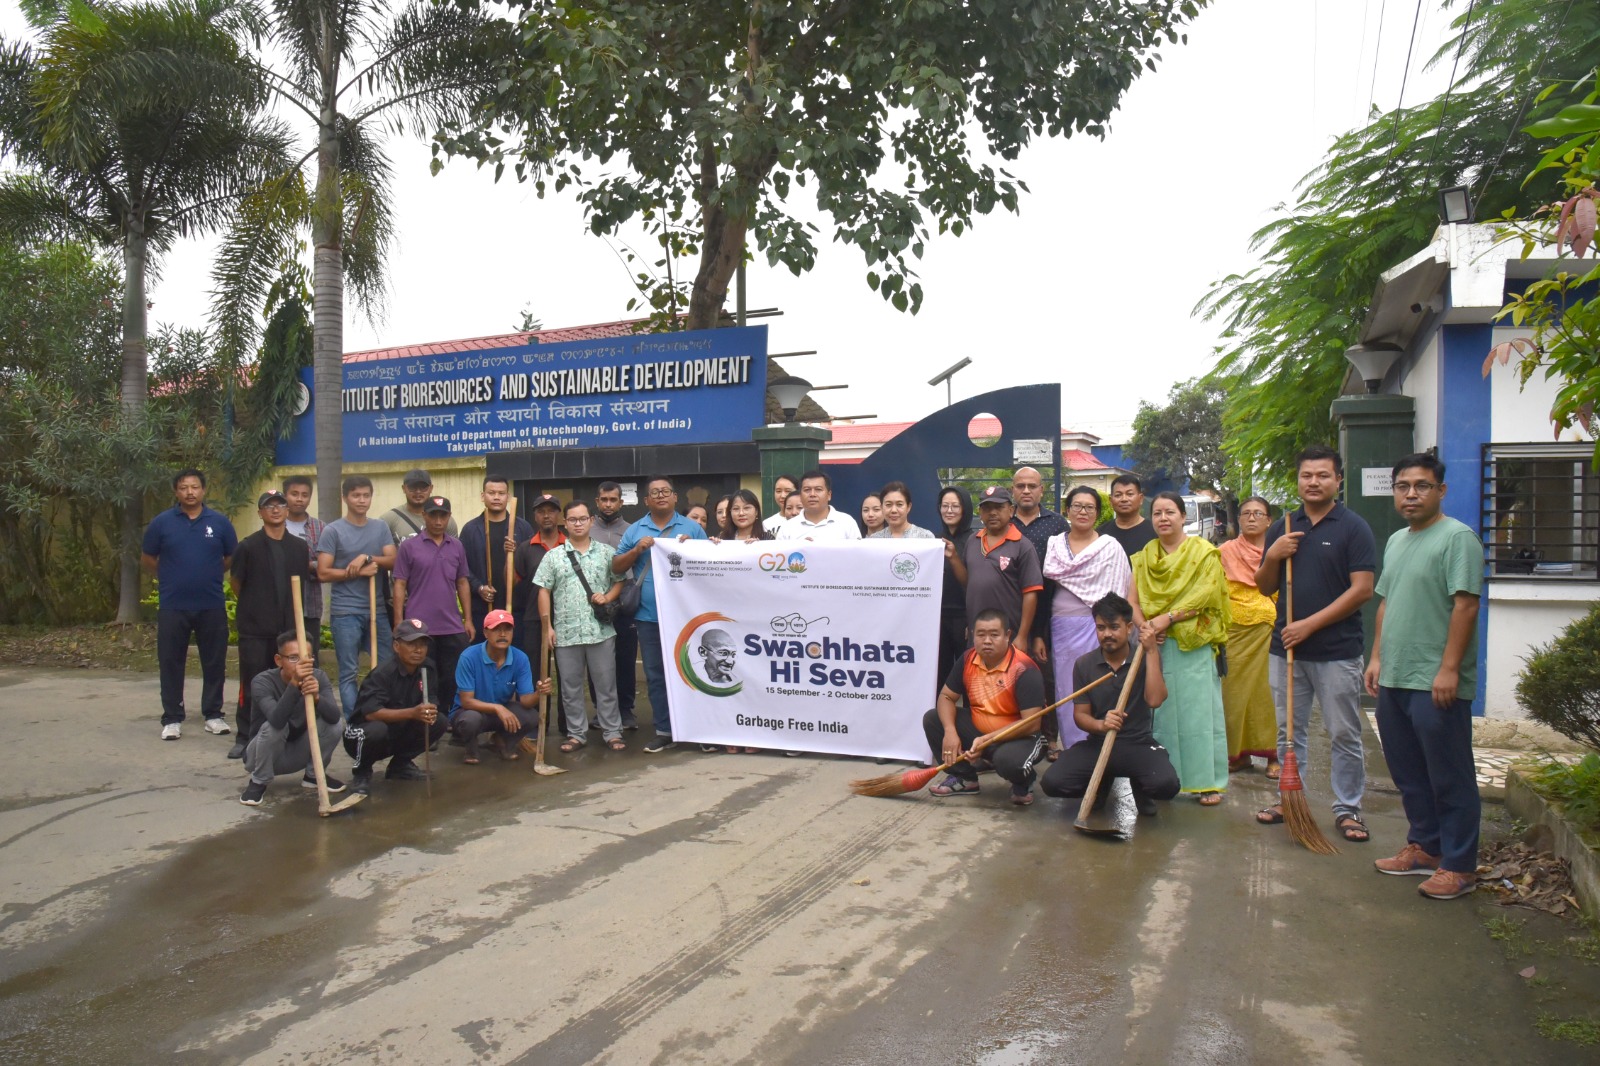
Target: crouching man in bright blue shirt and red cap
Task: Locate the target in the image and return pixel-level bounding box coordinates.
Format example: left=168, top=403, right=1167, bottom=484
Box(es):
left=450, top=611, right=550, bottom=765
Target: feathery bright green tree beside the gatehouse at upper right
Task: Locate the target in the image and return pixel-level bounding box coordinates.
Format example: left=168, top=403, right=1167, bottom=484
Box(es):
left=1197, top=0, right=1600, bottom=490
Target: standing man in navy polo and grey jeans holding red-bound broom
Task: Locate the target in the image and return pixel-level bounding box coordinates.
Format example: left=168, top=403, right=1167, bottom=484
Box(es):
left=1256, top=445, right=1378, bottom=844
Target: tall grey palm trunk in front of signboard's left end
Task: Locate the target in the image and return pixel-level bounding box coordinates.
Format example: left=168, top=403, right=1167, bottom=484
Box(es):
left=310, top=97, right=344, bottom=522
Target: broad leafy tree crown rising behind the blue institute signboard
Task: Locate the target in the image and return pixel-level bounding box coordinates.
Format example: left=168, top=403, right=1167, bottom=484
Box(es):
left=435, top=0, right=1202, bottom=330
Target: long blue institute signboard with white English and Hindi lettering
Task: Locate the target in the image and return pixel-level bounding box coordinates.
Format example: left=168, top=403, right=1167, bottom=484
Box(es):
left=277, top=327, right=766, bottom=466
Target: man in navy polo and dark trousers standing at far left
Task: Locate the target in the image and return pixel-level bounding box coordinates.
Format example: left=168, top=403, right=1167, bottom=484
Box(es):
left=139, top=469, right=238, bottom=739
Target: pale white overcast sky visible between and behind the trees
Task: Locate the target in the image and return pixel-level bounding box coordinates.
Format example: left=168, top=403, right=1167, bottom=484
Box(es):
left=0, top=0, right=1448, bottom=439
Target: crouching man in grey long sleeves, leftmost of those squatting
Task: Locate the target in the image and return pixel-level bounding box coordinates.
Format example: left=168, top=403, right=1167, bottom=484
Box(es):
left=238, top=632, right=344, bottom=807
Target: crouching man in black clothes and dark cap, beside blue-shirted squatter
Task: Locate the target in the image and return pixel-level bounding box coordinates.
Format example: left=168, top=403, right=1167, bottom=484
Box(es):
left=344, top=618, right=445, bottom=792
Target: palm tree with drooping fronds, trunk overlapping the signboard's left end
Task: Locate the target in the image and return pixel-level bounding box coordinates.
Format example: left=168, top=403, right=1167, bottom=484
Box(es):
left=214, top=0, right=494, bottom=520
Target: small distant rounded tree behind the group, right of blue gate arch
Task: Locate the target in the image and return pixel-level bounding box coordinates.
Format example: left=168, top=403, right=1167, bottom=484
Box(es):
left=1125, top=378, right=1238, bottom=498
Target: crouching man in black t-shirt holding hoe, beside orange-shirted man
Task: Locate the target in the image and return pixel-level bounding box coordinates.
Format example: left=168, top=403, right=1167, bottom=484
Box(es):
left=1038, top=592, right=1178, bottom=815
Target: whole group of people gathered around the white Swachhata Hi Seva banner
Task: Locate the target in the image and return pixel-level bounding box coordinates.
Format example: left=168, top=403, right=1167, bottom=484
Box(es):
left=144, top=445, right=1482, bottom=898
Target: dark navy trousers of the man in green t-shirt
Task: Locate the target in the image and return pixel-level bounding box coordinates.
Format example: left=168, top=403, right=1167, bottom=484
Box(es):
left=1378, top=687, right=1483, bottom=874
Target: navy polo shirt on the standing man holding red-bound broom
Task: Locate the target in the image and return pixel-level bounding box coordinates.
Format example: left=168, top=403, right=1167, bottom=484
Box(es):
left=1266, top=503, right=1378, bottom=663
